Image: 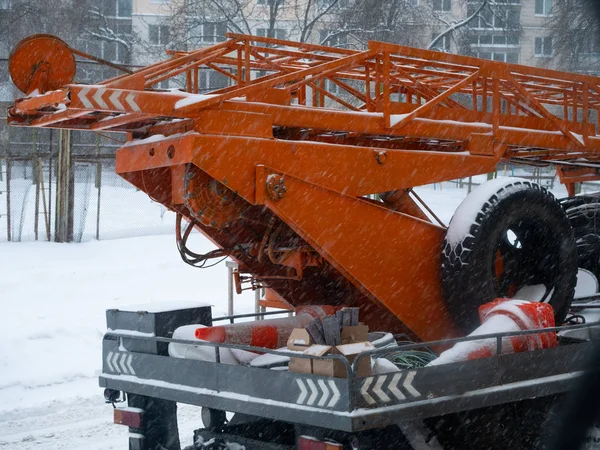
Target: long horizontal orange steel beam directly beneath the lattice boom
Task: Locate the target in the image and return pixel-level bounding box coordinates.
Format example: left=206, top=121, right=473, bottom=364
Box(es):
left=117, top=132, right=496, bottom=199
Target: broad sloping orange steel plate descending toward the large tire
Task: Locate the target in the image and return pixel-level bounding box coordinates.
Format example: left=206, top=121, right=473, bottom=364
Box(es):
left=257, top=171, right=458, bottom=340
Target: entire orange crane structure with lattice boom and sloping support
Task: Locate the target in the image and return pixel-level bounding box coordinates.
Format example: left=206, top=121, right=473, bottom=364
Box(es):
left=9, top=34, right=600, bottom=339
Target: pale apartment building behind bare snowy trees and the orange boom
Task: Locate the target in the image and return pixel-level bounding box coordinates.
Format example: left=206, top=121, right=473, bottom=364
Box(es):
left=0, top=0, right=592, bottom=103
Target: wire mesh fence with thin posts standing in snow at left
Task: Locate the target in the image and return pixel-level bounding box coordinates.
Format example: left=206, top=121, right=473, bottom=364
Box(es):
left=0, top=112, right=175, bottom=242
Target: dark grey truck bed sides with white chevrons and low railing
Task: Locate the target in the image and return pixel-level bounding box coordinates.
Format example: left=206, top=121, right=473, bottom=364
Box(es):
left=100, top=312, right=597, bottom=432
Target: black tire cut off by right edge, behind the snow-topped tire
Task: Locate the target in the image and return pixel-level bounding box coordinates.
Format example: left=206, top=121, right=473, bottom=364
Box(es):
left=560, top=195, right=600, bottom=280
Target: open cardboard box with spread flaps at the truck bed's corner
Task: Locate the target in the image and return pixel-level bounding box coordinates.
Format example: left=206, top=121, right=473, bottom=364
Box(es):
left=304, top=341, right=375, bottom=378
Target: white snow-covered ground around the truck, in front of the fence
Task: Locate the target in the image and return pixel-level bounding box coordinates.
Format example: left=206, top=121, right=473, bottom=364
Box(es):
left=0, top=177, right=596, bottom=450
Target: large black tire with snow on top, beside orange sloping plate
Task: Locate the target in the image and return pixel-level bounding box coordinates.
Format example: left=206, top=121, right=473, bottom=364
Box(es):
left=442, top=178, right=577, bottom=333
